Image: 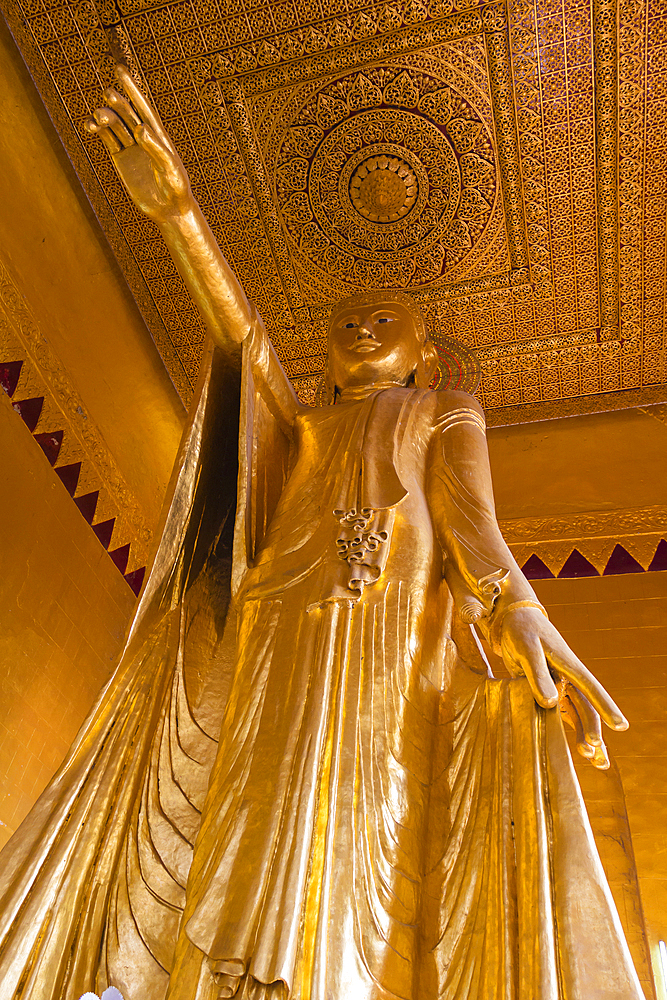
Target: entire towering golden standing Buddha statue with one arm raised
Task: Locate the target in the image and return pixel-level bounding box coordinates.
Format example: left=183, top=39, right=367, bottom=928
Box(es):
left=0, top=67, right=642, bottom=1000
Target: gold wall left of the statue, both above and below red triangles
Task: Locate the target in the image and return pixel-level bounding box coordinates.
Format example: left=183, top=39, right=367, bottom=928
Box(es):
left=0, top=13, right=185, bottom=845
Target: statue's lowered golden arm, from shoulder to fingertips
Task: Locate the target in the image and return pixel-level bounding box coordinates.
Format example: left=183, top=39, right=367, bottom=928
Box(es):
left=427, top=392, right=627, bottom=768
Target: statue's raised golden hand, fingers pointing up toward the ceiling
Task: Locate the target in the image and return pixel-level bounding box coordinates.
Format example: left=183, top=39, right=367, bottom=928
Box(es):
left=85, top=64, right=194, bottom=223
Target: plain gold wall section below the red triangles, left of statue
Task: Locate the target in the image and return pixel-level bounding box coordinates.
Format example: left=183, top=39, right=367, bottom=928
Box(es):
left=0, top=391, right=134, bottom=846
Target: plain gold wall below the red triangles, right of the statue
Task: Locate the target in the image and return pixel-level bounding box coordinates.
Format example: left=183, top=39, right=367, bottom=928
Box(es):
left=535, top=572, right=667, bottom=1000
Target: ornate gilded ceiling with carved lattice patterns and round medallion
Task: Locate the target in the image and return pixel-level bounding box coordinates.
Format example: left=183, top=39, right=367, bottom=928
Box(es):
left=2, top=0, right=667, bottom=423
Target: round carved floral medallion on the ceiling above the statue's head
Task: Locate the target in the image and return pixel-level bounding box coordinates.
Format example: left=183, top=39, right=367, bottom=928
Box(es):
left=275, top=66, right=497, bottom=287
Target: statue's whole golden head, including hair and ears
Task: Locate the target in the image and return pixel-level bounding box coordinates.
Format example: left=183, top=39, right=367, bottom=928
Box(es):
left=325, top=291, right=438, bottom=402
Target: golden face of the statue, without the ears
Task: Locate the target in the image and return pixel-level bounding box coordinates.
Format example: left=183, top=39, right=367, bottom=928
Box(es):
left=327, top=302, right=424, bottom=389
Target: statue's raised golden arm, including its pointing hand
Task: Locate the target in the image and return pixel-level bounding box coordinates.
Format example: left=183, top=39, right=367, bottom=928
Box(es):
left=86, top=58, right=298, bottom=438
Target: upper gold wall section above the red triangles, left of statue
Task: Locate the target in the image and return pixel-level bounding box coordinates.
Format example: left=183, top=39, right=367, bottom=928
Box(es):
left=0, top=11, right=185, bottom=541
